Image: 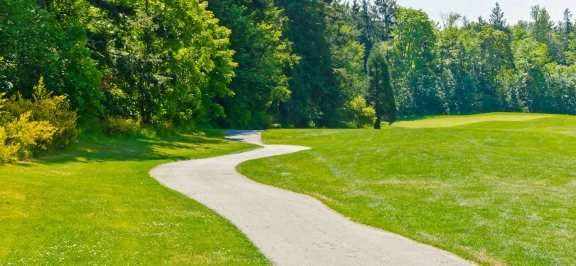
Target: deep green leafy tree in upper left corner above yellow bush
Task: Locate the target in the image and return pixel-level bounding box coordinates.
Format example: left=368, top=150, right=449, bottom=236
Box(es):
left=0, top=0, right=103, bottom=117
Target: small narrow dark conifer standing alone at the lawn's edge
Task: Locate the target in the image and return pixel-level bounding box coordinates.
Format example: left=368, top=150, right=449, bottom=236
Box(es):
left=366, top=44, right=396, bottom=129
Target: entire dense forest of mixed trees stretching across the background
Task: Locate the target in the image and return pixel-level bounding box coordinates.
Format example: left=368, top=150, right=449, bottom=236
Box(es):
left=0, top=0, right=576, bottom=160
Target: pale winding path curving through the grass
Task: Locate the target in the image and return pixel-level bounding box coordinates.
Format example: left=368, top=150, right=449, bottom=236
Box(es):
left=150, top=131, right=474, bottom=266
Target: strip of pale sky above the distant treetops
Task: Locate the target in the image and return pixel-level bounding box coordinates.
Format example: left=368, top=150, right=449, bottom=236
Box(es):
left=396, top=0, right=576, bottom=25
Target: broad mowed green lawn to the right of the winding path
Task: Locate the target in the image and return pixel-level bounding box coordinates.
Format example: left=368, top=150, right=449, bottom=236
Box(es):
left=239, top=113, right=576, bottom=265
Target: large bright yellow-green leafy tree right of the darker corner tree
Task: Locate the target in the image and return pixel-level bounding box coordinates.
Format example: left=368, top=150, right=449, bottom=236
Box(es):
left=59, top=0, right=236, bottom=126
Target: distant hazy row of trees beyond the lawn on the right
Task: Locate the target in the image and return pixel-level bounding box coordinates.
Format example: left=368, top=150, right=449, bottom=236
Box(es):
left=362, top=1, right=576, bottom=117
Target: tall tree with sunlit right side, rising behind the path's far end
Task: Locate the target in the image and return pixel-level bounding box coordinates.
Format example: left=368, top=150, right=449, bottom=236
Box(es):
left=208, top=0, right=298, bottom=128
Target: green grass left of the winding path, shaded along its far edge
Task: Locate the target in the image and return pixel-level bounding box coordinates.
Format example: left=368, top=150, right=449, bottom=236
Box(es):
left=0, top=132, right=270, bottom=265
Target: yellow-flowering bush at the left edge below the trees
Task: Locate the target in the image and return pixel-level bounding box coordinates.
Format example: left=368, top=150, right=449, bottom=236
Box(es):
left=5, top=78, right=78, bottom=148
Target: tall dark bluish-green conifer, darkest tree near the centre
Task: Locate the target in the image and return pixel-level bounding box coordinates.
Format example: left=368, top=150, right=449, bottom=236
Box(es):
left=278, top=0, right=346, bottom=127
